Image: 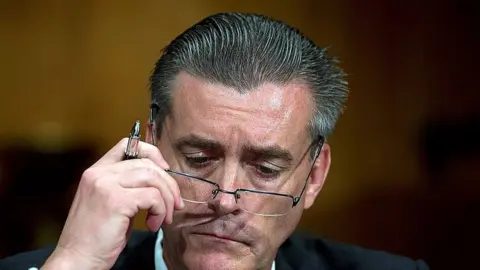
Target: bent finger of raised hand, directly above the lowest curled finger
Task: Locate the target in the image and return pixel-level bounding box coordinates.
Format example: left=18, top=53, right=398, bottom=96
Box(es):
left=110, top=159, right=184, bottom=210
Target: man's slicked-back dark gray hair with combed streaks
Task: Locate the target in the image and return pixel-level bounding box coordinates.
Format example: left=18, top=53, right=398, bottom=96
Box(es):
left=150, top=13, right=348, bottom=150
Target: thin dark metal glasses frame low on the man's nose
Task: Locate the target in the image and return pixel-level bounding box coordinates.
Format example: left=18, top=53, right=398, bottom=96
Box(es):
left=149, top=103, right=325, bottom=216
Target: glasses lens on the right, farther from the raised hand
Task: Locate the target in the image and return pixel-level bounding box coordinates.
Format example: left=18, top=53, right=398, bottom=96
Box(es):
left=237, top=191, right=293, bottom=216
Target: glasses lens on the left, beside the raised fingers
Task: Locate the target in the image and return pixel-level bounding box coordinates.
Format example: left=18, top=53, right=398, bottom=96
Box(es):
left=171, top=173, right=217, bottom=203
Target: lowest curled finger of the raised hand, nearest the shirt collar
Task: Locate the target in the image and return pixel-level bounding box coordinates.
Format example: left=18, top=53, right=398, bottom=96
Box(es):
left=127, top=187, right=168, bottom=231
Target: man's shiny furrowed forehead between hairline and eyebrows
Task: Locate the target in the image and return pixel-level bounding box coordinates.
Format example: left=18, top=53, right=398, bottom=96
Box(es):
left=167, top=73, right=313, bottom=150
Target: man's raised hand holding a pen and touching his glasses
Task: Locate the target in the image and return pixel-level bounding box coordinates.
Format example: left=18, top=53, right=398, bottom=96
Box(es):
left=42, top=139, right=184, bottom=269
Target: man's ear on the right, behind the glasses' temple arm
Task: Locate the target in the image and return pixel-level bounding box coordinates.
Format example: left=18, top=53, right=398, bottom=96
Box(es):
left=304, top=143, right=330, bottom=209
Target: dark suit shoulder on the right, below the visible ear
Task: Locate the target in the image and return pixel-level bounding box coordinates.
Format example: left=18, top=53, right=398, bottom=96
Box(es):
left=286, top=233, right=429, bottom=270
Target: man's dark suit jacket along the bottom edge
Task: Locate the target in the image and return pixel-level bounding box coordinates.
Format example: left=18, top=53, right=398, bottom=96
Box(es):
left=0, top=231, right=428, bottom=270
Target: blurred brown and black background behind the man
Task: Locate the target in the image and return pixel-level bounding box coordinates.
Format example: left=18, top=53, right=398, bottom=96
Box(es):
left=0, top=0, right=480, bottom=269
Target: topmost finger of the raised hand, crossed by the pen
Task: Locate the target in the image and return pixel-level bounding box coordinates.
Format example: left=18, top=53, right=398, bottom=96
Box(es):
left=94, top=138, right=169, bottom=169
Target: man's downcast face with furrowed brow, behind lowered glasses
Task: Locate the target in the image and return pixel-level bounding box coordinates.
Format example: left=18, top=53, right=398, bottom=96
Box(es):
left=159, top=73, right=329, bottom=269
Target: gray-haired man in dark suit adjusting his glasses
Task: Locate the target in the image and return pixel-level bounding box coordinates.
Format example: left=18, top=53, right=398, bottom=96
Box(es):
left=0, top=13, right=427, bottom=270
